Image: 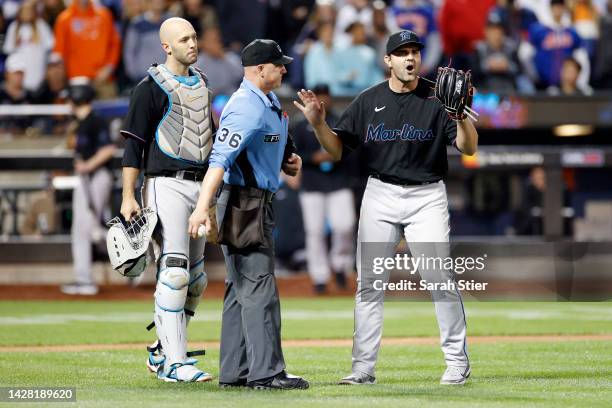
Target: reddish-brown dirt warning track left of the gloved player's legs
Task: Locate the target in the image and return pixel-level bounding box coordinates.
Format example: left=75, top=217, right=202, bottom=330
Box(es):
left=0, top=274, right=355, bottom=301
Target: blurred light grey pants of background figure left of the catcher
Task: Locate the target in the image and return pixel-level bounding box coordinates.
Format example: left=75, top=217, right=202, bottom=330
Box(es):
left=72, top=167, right=113, bottom=284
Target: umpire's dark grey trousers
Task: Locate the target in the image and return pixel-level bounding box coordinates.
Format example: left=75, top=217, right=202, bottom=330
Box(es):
left=217, top=186, right=285, bottom=383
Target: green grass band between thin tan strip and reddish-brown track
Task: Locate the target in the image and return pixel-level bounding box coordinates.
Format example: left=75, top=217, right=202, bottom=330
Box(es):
left=0, top=298, right=612, bottom=345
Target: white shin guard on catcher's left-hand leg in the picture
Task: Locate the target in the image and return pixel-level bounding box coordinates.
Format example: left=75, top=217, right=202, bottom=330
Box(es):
left=155, top=254, right=189, bottom=374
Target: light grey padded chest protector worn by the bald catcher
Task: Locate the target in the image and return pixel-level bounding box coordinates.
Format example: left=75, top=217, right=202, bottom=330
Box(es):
left=149, top=65, right=213, bottom=163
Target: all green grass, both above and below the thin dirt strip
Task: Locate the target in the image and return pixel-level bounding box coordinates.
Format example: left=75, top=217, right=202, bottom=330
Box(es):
left=0, top=299, right=612, bottom=408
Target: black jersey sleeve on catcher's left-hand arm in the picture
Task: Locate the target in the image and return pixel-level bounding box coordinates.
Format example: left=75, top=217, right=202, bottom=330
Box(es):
left=120, top=77, right=155, bottom=143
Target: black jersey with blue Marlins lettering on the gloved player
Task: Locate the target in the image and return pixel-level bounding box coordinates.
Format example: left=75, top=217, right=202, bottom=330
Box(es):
left=334, top=81, right=457, bottom=184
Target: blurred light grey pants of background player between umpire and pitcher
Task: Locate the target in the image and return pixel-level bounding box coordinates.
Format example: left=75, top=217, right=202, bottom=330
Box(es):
left=300, top=188, right=355, bottom=284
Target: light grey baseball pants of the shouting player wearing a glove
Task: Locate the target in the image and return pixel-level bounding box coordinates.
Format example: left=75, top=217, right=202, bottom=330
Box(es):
left=353, top=178, right=469, bottom=375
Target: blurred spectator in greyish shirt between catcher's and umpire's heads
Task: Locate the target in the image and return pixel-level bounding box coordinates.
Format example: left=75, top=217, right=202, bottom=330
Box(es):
left=196, top=26, right=243, bottom=96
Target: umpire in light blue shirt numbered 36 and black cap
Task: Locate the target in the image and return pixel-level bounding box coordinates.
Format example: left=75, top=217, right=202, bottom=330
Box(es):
left=189, top=39, right=309, bottom=389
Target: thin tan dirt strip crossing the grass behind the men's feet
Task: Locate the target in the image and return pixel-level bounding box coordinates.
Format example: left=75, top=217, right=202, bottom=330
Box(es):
left=0, top=334, right=612, bottom=353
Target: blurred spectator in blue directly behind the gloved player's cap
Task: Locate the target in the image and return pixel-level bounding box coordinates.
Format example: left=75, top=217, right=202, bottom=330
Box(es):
left=390, top=0, right=442, bottom=76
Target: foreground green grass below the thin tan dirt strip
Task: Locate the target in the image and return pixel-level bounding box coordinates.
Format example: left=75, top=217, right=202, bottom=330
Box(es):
left=0, top=342, right=612, bottom=408
